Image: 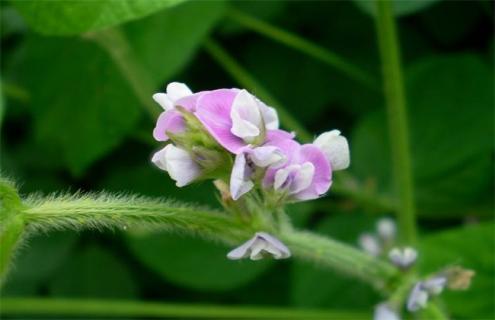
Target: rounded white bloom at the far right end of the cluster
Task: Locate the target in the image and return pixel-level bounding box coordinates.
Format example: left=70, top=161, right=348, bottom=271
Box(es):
left=313, top=130, right=351, bottom=171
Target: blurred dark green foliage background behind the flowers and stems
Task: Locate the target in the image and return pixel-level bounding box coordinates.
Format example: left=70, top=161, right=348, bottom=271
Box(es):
left=0, top=0, right=495, bottom=319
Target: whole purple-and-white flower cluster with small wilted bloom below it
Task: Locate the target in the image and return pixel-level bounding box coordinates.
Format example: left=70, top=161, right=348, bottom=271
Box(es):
left=152, top=82, right=349, bottom=259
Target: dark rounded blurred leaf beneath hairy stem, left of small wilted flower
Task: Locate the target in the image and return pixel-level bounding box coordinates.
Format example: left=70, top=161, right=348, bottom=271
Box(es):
left=128, top=234, right=271, bottom=291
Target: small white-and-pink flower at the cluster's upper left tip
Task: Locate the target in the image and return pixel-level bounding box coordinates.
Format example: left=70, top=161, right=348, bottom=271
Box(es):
left=153, top=82, right=205, bottom=141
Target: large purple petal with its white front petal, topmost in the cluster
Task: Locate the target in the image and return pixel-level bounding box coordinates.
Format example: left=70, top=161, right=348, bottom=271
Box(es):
left=195, top=89, right=278, bottom=154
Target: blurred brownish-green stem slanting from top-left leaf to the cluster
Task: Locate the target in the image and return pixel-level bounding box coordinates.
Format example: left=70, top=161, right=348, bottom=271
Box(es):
left=85, top=28, right=160, bottom=121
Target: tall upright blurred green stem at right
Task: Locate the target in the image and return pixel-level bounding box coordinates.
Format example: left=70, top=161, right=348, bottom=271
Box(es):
left=376, top=0, right=416, bottom=244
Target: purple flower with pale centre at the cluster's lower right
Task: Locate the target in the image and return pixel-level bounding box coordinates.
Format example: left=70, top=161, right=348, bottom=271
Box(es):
left=263, top=139, right=332, bottom=201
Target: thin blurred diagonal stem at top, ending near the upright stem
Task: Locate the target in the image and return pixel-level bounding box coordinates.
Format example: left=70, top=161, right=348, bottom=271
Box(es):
left=227, top=7, right=378, bottom=89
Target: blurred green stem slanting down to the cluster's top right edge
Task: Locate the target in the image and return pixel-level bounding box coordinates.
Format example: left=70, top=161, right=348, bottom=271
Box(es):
left=204, top=39, right=313, bottom=141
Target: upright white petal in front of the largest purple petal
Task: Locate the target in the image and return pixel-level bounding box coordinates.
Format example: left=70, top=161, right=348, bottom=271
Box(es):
left=230, top=90, right=263, bottom=143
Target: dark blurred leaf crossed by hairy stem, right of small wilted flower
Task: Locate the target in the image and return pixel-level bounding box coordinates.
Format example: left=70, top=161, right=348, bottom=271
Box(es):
left=291, top=214, right=378, bottom=309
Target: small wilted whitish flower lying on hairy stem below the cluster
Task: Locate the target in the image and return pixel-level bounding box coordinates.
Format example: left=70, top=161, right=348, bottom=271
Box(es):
left=227, top=232, right=291, bottom=260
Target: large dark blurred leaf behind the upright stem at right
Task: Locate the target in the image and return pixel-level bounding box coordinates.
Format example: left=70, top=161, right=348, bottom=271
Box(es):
left=351, top=55, right=493, bottom=217
